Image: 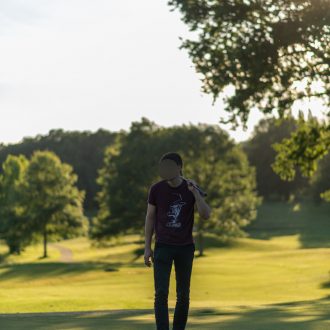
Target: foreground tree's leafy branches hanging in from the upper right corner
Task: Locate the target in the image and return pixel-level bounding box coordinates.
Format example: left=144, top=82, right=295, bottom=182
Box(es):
left=168, top=0, right=330, bottom=184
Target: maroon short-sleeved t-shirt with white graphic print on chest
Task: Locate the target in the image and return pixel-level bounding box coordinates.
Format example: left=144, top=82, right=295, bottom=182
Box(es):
left=147, top=180, right=195, bottom=245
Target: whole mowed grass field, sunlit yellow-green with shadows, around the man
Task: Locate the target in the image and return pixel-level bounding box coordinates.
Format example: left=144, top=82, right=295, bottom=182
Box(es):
left=0, top=203, right=330, bottom=330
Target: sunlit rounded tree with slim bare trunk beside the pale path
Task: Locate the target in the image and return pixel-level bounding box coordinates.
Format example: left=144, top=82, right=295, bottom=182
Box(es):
left=24, top=150, right=88, bottom=258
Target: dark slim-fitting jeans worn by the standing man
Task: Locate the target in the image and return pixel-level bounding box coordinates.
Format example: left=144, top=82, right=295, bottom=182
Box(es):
left=154, top=242, right=195, bottom=330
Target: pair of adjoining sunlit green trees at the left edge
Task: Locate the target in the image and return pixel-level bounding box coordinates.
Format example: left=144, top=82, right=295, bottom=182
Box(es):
left=0, top=151, right=88, bottom=257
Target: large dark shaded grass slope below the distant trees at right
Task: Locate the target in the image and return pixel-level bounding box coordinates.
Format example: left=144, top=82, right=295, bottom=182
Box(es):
left=245, top=201, right=330, bottom=248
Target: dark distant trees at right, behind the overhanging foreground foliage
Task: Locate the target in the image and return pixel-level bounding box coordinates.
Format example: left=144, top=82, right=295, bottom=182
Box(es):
left=241, top=117, right=330, bottom=202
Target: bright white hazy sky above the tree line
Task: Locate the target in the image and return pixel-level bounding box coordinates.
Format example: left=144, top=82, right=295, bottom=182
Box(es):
left=0, top=0, right=324, bottom=143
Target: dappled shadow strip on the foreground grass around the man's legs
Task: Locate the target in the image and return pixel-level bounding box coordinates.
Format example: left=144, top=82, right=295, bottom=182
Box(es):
left=0, top=296, right=330, bottom=330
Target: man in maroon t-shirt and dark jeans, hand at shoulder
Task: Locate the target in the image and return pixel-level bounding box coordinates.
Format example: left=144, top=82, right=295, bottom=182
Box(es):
left=144, top=152, right=211, bottom=330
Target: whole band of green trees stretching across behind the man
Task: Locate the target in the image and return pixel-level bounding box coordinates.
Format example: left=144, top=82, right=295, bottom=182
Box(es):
left=0, top=117, right=330, bottom=257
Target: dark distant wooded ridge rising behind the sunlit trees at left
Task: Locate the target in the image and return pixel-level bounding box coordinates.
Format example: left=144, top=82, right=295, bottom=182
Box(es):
left=0, top=129, right=118, bottom=212
